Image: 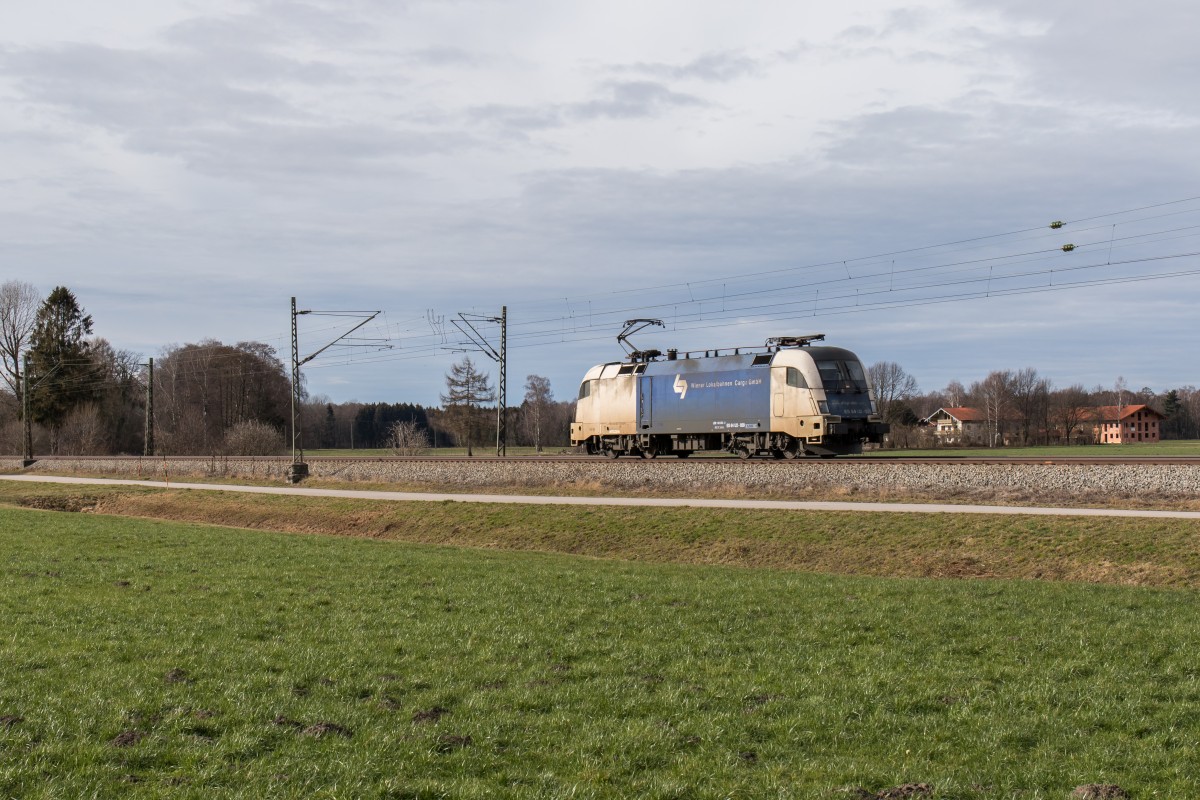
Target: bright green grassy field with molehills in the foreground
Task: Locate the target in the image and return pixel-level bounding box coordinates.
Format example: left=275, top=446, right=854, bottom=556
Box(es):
left=0, top=509, right=1200, bottom=799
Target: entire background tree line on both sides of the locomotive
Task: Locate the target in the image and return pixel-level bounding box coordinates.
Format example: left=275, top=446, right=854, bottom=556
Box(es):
left=0, top=281, right=1200, bottom=455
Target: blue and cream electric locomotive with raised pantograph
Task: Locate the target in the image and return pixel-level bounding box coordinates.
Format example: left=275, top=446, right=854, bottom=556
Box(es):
left=571, top=320, right=888, bottom=458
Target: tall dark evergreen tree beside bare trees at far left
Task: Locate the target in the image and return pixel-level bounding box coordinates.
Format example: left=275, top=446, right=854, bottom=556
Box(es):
left=29, top=287, right=98, bottom=453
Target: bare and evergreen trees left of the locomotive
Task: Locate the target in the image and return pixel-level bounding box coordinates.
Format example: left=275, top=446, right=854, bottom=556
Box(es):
left=0, top=281, right=574, bottom=456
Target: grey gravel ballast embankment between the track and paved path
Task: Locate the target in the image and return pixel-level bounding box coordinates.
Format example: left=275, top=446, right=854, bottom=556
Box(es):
left=0, top=457, right=1200, bottom=500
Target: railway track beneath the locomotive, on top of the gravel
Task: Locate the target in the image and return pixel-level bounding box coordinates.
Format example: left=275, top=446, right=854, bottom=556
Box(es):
left=13, top=455, right=1200, bottom=469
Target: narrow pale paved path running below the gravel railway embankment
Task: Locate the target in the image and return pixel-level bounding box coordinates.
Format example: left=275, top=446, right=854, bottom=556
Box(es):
left=0, top=475, right=1200, bottom=519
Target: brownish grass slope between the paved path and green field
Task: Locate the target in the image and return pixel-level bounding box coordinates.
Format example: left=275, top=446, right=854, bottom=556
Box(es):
left=7, top=482, right=1200, bottom=589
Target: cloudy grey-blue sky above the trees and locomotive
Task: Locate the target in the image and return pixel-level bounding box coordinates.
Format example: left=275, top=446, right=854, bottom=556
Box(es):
left=0, top=0, right=1200, bottom=404
